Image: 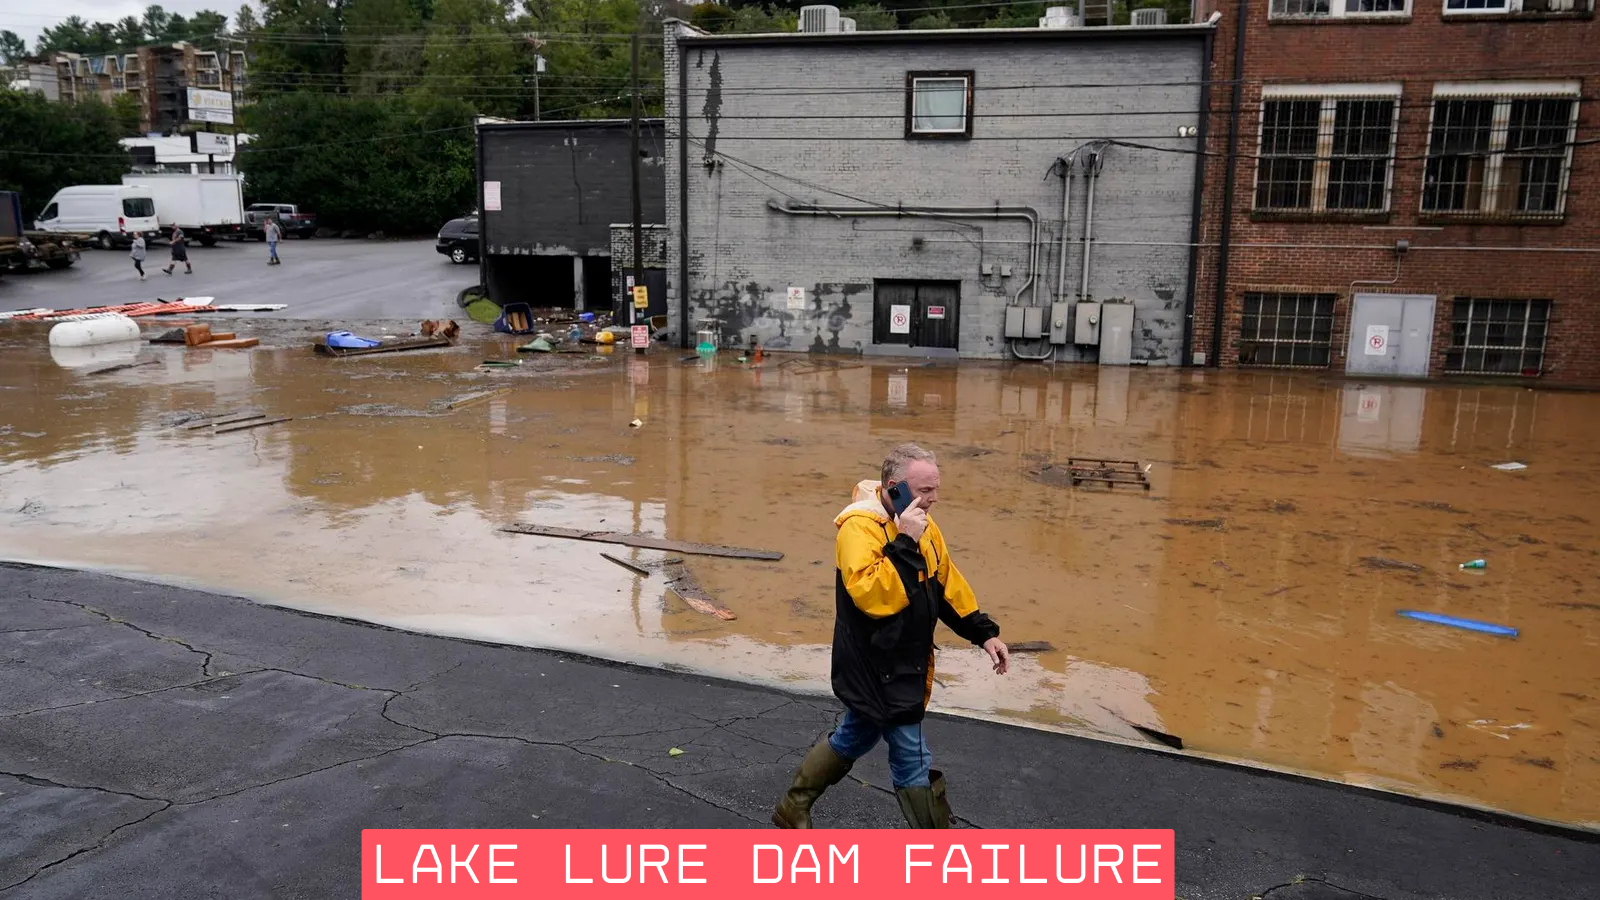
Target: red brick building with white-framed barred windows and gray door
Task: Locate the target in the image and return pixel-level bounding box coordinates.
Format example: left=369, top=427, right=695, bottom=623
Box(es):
left=1192, top=0, right=1600, bottom=384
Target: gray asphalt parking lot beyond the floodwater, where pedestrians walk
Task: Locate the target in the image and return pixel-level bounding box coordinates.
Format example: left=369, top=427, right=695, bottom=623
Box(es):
left=0, top=239, right=478, bottom=320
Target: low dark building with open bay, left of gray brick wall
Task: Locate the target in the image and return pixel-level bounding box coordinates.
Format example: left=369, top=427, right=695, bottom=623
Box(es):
left=478, top=119, right=666, bottom=309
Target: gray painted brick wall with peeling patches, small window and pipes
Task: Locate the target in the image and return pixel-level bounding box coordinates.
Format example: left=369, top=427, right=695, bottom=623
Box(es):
left=666, top=22, right=1203, bottom=357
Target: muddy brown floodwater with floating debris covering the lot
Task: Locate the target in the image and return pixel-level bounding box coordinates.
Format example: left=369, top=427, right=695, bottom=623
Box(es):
left=0, top=320, right=1600, bottom=828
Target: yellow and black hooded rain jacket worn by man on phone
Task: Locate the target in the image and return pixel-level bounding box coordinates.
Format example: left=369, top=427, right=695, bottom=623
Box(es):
left=832, top=480, right=1000, bottom=725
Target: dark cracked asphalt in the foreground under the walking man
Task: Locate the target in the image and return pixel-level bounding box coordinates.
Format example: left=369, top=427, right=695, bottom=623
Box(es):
left=0, top=564, right=1600, bottom=900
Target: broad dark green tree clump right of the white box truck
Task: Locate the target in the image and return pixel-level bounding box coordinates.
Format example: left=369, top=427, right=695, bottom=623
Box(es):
left=238, top=91, right=477, bottom=234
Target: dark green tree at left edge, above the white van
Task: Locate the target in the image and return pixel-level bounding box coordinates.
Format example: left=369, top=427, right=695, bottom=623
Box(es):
left=0, top=88, right=130, bottom=212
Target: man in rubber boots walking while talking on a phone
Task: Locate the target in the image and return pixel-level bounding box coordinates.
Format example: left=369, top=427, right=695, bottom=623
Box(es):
left=773, top=444, right=1010, bottom=828
